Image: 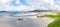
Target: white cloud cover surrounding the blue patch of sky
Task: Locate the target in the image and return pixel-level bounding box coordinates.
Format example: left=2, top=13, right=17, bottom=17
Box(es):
left=1, top=0, right=60, bottom=11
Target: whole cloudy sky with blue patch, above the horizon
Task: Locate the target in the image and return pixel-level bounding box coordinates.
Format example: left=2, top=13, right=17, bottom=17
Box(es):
left=0, top=0, right=60, bottom=11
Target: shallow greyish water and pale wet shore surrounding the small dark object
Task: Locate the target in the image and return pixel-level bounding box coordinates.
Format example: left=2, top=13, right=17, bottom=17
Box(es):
left=0, top=17, right=53, bottom=27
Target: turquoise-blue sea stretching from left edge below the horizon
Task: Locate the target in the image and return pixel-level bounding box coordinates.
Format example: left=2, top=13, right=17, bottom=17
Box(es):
left=0, top=11, right=29, bottom=18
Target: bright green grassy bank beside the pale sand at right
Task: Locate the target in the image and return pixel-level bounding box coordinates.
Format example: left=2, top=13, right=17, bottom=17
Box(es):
left=46, top=12, right=60, bottom=27
